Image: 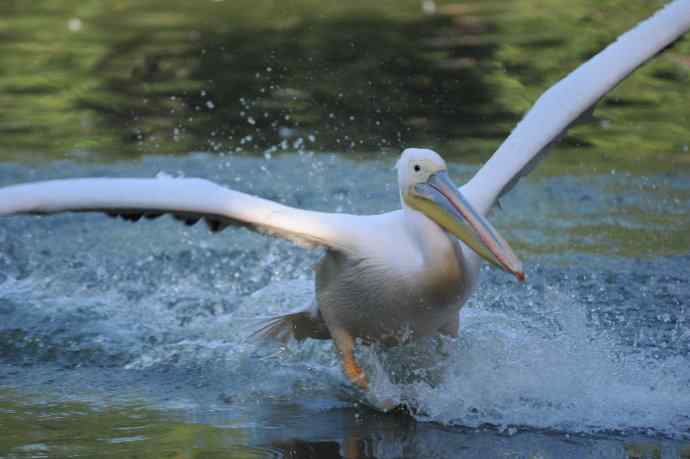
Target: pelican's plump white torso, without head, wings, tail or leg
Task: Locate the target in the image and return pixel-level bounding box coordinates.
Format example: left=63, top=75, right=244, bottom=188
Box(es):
left=310, top=209, right=472, bottom=344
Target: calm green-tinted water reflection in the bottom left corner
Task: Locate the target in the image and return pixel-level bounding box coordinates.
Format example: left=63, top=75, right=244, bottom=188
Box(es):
left=0, top=390, right=268, bottom=459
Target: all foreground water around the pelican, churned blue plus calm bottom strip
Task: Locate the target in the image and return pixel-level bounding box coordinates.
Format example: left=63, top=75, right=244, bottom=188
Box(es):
left=0, top=153, right=690, bottom=457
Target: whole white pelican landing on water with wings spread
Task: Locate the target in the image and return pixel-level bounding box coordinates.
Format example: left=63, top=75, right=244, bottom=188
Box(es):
left=0, top=0, right=690, bottom=390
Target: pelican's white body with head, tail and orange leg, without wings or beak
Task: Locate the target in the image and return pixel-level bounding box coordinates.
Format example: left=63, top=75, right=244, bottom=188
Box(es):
left=259, top=149, right=500, bottom=388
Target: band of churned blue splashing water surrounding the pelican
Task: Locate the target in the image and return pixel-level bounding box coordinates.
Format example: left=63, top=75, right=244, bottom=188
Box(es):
left=0, top=155, right=690, bottom=437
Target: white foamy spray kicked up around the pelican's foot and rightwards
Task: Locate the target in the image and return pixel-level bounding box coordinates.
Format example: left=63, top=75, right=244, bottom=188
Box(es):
left=239, top=281, right=690, bottom=436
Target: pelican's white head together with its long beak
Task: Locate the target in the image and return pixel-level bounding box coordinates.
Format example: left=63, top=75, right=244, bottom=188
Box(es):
left=396, top=148, right=525, bottom=280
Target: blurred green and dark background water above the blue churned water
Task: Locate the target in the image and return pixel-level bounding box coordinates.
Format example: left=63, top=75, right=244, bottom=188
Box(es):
left=0, top=0, right=690, bottom=172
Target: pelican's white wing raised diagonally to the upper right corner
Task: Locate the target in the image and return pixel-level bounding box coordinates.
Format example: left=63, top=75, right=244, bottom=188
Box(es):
left=463, top=0, right=690, bottom=212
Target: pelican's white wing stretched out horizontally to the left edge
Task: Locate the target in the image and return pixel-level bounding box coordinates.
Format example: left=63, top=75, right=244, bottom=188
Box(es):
left=0, top=178, right=357, bottom=250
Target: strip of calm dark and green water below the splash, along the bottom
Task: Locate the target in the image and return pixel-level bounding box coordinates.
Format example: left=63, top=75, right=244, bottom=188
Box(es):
left=0, top=390, right=690, bottom=459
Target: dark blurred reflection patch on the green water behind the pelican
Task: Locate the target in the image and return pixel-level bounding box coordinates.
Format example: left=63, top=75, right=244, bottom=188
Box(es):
left=94, top=13, right=510, bottom=155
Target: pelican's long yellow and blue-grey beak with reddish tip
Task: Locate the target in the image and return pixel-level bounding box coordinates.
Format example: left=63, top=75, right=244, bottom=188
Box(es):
left=405, top=170, right=525, bottom=281
